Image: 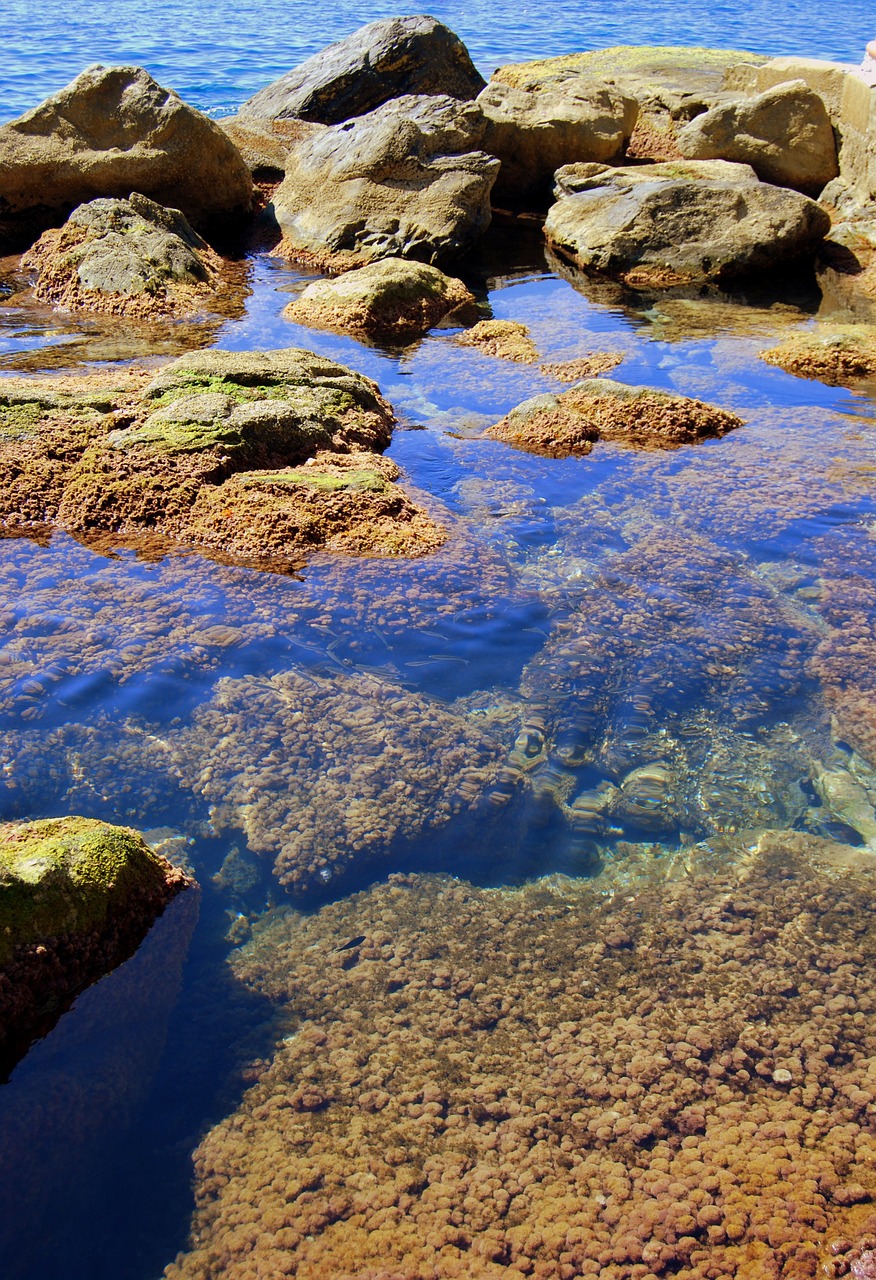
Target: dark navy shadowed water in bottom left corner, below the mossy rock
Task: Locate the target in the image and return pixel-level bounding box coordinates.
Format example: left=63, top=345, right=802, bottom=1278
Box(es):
left=0, top=891, right=273, bottom=1280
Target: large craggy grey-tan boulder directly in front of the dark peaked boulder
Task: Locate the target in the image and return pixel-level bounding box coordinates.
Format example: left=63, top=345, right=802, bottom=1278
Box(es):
left=273, top=96, right=499, bottom=270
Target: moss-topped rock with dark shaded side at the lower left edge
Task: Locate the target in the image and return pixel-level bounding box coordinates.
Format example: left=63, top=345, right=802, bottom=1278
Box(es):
left=0, top=818, right=192, bottom=1069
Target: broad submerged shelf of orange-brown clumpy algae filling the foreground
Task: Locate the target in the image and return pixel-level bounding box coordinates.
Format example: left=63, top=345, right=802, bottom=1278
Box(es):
left=165, top=833, right=876, bottom=1280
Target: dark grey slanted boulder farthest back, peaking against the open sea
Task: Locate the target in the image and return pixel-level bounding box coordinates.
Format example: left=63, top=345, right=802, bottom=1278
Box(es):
left=241, top=17, right=484, bottom=124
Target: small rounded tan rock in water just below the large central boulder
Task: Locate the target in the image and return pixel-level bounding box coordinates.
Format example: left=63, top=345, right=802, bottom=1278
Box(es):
left=283, top=257, right=475, bottom=338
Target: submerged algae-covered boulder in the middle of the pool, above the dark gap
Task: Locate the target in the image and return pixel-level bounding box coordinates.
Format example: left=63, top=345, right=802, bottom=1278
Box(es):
left=168, top=669, right=517, bottom=891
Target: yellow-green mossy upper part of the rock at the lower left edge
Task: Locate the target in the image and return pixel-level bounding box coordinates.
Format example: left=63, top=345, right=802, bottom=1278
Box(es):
left=0, top=818, right=180, bottom=966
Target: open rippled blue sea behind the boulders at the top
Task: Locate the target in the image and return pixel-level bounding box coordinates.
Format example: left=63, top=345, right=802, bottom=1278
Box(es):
left=0, top=0, right=876, bottom=119
